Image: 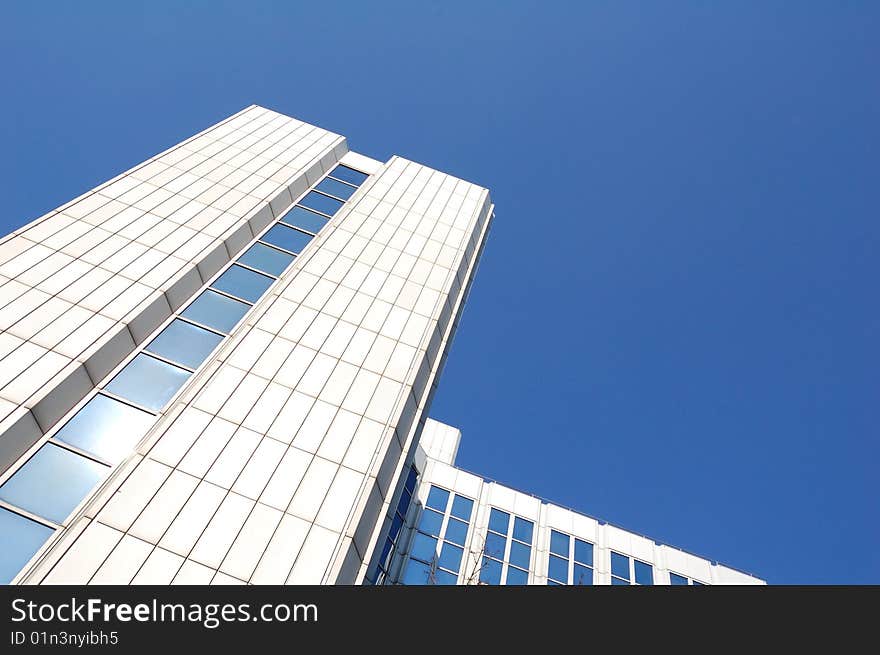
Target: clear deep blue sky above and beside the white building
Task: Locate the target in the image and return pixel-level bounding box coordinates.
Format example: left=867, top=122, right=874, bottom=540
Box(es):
left=0, top=1, right=880, bottom=583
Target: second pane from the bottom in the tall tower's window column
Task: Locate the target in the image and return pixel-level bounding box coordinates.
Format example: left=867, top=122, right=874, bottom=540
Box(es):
left=0, top=443, right=109, bottom=524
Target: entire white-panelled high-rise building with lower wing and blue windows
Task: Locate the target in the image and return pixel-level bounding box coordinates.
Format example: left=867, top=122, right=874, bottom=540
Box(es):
left=0, top=106, right=757, bottom=584
